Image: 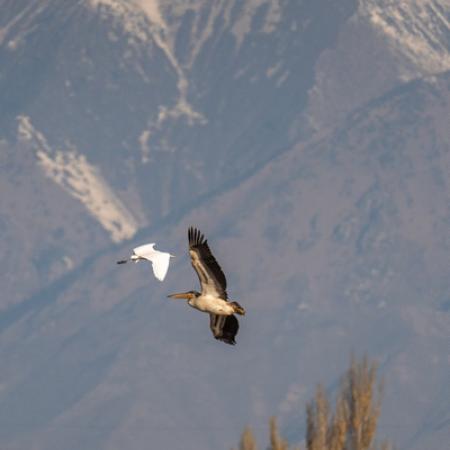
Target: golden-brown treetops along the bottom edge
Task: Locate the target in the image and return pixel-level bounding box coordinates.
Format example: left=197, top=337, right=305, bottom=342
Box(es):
left=239, top=358, right=390, bottom=450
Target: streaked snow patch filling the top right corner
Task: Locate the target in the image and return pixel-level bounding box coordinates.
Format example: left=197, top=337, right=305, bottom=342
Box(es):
left=358, top=0, right=450, bottom=78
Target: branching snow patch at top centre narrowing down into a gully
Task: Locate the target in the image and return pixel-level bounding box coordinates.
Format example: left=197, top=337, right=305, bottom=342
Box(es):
left=86, top=0, right=283, bottom=133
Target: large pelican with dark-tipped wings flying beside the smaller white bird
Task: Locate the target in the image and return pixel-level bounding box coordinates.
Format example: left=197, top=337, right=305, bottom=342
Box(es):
left=168, top=227, right=245, bottom=345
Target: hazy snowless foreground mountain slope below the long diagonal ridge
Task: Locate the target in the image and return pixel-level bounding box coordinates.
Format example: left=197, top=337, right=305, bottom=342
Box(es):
left=0, top=74, right=450, bottom=449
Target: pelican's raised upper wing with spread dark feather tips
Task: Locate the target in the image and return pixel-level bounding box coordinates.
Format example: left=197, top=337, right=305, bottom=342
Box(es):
left=188, top=227, right=227, bottom=300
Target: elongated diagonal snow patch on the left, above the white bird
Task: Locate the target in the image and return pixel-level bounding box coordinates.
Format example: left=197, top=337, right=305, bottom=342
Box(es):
left=18, top=116, right=139, bottom=242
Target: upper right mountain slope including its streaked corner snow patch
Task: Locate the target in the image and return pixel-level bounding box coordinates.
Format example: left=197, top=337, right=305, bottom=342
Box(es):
left=303, top=0, right=450, bottom=130
